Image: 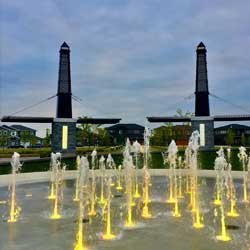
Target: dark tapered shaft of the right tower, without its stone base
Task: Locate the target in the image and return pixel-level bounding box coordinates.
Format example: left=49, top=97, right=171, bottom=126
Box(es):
left=195, top=42, right=210, bottom=116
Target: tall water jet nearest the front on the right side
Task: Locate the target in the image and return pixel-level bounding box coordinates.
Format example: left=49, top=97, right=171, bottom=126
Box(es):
left=214, top=147, right=231, bottom=241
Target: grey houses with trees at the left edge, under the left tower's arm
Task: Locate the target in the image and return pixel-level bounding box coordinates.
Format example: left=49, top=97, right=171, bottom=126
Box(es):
left=0, top=125, right=43, bottom=147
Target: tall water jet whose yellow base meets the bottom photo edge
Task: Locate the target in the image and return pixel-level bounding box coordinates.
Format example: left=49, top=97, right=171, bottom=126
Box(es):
left=74, top=156, right=89, bottom=250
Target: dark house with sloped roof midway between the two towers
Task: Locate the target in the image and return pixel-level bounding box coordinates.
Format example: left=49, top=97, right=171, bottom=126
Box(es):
left=107, top=123, right=145, bottom=145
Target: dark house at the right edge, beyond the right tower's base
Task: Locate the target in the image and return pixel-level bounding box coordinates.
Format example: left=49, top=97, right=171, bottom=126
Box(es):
left=214, top=124, right=250, bottom=145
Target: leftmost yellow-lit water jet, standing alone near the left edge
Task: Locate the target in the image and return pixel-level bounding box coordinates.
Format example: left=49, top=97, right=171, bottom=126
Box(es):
left=8, top=152, right=22, bottom=223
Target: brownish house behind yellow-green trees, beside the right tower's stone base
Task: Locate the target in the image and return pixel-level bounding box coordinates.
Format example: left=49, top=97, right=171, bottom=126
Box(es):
left=151, top=125, right=192, bottom=146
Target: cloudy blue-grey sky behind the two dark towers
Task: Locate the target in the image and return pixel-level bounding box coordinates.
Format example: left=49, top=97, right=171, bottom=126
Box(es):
left=0, top=0, right=250, bottom=135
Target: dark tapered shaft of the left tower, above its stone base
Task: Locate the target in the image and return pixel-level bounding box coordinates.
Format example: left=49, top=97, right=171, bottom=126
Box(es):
left=56, top=42, right=72, bottom=118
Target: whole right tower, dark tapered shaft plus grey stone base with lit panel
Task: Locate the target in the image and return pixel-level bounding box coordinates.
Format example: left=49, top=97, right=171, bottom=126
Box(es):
left=191, top=42, right=214, bottom=149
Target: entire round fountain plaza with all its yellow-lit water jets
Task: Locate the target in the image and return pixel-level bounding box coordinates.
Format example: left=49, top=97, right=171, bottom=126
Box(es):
left=0, top=129, right=250, bottom=250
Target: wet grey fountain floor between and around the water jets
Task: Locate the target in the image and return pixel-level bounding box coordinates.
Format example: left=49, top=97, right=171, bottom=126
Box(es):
left=0, top=177, right=250, bottom=250
